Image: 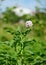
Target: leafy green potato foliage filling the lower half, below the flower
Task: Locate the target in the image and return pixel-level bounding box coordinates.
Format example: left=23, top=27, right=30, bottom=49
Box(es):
left=0, top=28, right=46, bottom=65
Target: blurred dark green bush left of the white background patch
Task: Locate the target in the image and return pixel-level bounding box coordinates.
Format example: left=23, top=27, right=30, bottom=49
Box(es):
left=3, top=8, right=20, bottom=23
